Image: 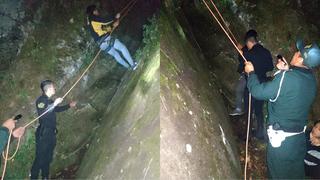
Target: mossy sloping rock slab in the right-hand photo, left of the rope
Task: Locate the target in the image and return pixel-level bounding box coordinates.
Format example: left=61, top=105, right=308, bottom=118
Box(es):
left=160, top=1, right=240, bottom=179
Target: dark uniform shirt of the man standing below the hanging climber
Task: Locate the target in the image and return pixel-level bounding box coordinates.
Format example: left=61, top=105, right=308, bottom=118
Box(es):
left=36, top=95, right=70, bottom=129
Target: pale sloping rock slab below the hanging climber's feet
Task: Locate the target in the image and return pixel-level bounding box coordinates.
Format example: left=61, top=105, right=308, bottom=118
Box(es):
left=77, top=16, right=160, bottom=180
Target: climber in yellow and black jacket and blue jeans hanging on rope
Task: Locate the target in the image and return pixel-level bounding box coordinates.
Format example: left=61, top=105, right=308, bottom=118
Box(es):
left=87, top=5, right=137, bottom=70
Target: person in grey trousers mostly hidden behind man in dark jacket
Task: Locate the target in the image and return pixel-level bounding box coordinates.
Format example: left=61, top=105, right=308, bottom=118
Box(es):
left=229, top=44, right=248, bottom=116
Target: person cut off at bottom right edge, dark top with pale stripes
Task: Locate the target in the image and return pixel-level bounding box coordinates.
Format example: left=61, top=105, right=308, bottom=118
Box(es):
left=304, top=120, right=320, bottom=179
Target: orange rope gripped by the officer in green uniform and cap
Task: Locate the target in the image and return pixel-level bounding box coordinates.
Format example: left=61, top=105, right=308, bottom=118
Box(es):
left=202, top=0, right=252, bottom=180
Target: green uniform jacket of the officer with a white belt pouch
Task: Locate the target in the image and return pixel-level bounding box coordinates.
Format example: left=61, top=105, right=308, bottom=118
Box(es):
left=247, top=67, right=317, bottom=130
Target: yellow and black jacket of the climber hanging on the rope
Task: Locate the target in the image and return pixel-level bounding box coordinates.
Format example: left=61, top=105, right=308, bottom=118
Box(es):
left=87, top=15, right=114, bottom=42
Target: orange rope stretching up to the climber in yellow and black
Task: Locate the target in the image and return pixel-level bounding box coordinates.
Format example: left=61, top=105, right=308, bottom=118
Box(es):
left=1, top=0, right=138, bottom=180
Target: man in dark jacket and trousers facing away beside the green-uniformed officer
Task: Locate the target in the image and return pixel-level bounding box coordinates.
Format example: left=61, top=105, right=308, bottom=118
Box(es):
left=230, top=29, right=274, bottom=140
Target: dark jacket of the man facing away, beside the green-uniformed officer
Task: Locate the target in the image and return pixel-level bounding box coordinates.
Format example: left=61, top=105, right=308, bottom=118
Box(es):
left=243, top=43, right=273, bottom=82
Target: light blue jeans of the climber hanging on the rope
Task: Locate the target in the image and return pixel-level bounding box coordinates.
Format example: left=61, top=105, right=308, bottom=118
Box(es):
left=100, top=36, right=134, bottom=68
